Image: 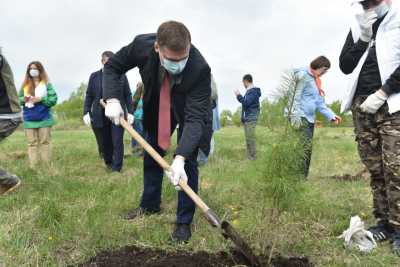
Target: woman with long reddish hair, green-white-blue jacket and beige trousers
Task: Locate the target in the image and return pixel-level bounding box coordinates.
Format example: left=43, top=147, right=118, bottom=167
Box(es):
left=19, top=61, right=57, bottom=168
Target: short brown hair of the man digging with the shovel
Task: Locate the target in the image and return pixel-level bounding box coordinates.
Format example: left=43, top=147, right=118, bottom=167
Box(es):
left=157, top=20, right=191, bottom=52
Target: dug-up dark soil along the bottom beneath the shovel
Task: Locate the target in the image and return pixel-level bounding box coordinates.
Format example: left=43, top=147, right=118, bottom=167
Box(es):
left=77, top=246, right=313, bottom=267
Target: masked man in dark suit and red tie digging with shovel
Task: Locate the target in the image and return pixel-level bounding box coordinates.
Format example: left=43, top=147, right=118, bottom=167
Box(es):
left=103, top=21, right=212, bottom=242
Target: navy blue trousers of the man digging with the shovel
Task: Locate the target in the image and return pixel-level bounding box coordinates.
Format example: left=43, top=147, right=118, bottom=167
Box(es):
left=140, top=131, right=199, bottom=224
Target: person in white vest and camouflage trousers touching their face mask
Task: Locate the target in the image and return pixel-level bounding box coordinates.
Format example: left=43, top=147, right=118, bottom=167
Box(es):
left=339, top=0, right=400, bottom=256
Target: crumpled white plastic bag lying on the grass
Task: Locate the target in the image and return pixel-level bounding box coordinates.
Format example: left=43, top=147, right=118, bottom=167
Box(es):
left=338, top=216, right=377, bottom=252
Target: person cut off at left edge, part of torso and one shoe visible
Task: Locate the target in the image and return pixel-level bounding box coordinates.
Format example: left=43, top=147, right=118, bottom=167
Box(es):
left=0, top=50, right=22, bottom=195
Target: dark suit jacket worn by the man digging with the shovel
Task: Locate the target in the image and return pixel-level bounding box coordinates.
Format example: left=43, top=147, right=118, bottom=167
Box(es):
left=103, top=33, right=212, bottom=158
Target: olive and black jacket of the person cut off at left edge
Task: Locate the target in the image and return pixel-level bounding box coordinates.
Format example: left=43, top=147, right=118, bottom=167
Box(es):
left=0, top=54, right=21, bottom=114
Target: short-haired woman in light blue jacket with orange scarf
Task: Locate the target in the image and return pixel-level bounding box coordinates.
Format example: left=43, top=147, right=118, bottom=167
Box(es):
left=289, top=56, right=342, bottom=178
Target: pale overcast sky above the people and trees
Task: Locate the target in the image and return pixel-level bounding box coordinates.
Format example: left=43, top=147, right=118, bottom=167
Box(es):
left=0, top=0, right=350, bottom=113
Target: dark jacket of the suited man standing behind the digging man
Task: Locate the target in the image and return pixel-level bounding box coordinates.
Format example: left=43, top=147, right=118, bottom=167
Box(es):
left=83, top=70, right=133, bottom=128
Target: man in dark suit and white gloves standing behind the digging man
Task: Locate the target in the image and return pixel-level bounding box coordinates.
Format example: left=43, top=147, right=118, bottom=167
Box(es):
left=83, top=51, right=133, bottom=172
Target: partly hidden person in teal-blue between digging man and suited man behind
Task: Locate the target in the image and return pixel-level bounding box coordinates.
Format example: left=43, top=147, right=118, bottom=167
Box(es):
left=132, top=82, right=144, bottom=156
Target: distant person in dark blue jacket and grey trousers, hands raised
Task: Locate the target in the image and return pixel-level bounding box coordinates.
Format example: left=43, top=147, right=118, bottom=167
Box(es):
left=235, top=74, right=261, bottom=160
